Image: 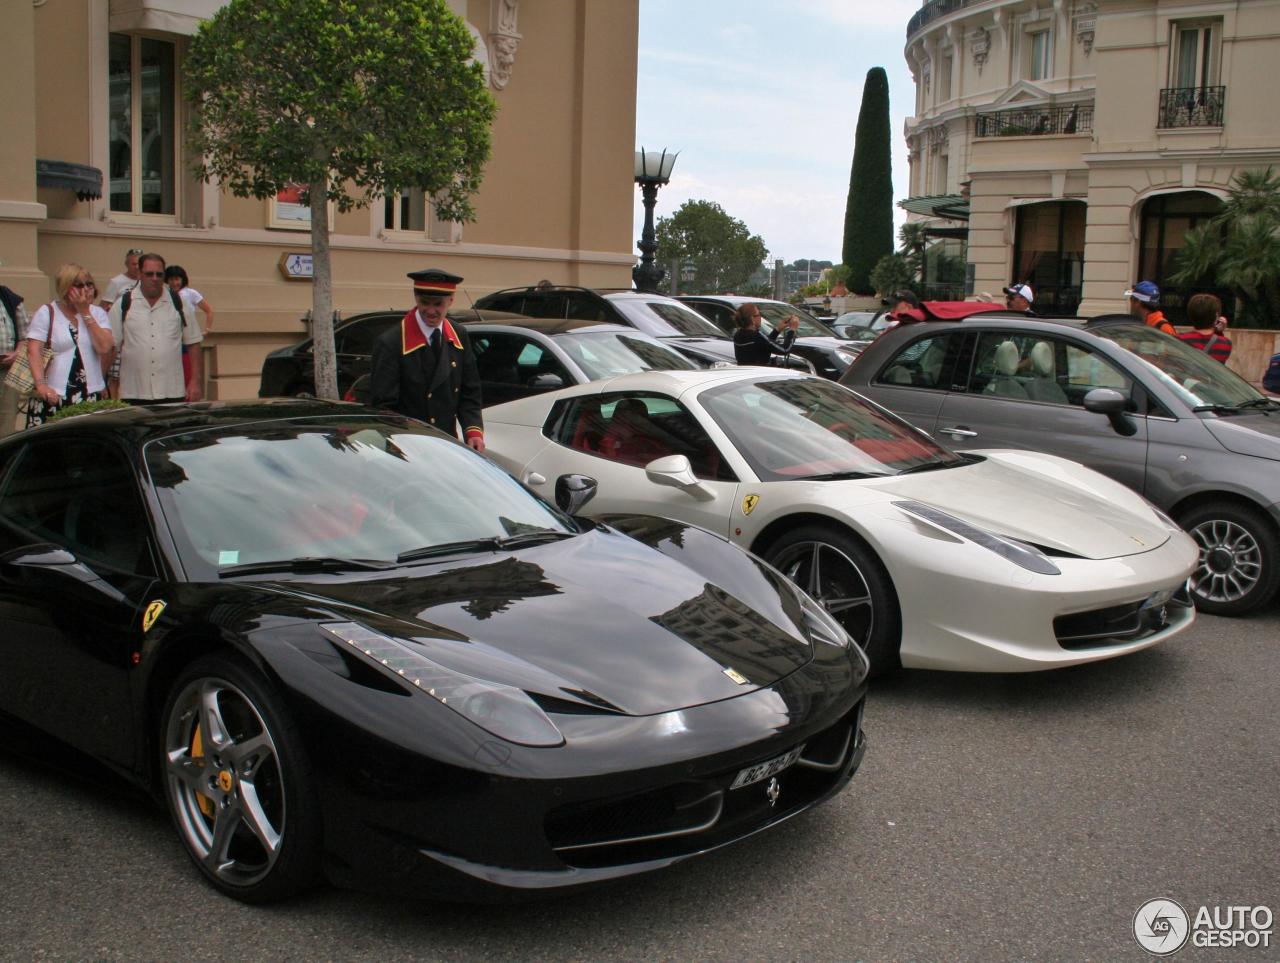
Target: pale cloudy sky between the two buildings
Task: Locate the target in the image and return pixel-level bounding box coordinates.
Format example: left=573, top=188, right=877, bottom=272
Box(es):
left=635, top=0, right=920, bottom=264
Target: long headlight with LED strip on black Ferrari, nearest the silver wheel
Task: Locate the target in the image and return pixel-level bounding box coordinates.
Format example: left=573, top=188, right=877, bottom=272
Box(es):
left=321, top=622, right=564, bottom=745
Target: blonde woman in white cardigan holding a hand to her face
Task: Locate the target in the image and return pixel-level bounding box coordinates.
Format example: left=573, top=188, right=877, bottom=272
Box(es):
left=27, top=264, right=114, bottom=428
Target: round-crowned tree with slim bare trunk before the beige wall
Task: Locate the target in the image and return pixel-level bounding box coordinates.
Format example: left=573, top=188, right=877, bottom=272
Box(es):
left=184, top=0, right=495, bottom=398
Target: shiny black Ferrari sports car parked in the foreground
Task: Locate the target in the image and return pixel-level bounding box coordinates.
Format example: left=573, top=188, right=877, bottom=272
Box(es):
left=0, top=401, right=867, bottom=902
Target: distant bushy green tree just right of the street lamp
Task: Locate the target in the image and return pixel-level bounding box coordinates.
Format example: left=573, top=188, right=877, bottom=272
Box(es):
left=654, top=201, right=769, bottom=295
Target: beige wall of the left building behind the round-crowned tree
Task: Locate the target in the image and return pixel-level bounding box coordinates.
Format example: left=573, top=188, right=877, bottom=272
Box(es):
left=0, top=0, right=639, bottom=398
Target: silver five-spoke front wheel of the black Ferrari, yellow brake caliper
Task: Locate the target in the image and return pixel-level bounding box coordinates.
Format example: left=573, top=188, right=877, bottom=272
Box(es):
left=160, top=656, right=321, bottom=903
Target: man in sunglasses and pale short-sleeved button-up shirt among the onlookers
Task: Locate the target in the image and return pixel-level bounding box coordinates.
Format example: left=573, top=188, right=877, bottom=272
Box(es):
left=110, top=254, right=205, bottom=405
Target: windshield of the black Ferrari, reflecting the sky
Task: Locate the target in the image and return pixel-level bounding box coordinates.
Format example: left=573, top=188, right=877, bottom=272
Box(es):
left=145, top=416, right=576, bottom=579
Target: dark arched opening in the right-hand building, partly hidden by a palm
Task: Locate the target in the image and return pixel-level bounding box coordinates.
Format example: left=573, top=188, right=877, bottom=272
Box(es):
left=1134, top=191, right=1235, bottom=324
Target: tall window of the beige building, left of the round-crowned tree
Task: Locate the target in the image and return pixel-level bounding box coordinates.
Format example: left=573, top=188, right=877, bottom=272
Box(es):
left=108, top=33, right=178, bottom=215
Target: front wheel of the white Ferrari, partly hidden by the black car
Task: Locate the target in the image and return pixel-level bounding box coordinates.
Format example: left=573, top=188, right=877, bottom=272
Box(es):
left=767, top=525, right=902, bottom=677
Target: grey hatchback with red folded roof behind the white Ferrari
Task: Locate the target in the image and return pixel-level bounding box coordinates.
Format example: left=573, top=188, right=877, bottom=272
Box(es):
left=840, top=315, right=1280, bottom=615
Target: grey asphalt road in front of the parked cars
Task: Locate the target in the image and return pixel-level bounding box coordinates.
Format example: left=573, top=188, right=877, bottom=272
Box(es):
left=0, top=606, right=1280, bottom=963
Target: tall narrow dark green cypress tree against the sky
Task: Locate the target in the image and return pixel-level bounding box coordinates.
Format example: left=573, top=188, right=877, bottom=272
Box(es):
left=842, top=67, right=893, bottom=295
